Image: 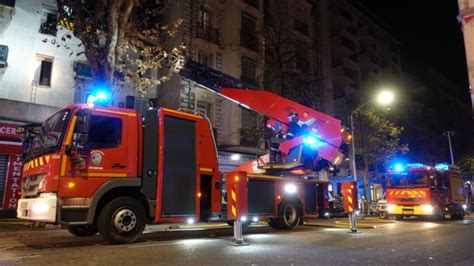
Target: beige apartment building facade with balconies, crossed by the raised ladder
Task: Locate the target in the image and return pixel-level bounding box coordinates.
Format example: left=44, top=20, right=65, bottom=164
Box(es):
left=157, top=0, right=264, bottom=150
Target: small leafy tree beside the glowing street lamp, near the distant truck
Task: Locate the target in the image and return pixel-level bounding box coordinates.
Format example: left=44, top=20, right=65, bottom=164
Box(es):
left=354, top=108, right=408, bottom=211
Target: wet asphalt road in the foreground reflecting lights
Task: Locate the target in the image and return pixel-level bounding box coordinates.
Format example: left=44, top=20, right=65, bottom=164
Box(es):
left=0, top=218, right=474, bottom=265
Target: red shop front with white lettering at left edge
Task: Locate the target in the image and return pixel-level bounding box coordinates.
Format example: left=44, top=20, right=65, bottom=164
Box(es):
left=0, top=123, right=22, bottom=211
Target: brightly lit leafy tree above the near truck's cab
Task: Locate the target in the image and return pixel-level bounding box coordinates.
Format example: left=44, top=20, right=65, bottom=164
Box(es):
left=53, top=0, right=184, bottom=95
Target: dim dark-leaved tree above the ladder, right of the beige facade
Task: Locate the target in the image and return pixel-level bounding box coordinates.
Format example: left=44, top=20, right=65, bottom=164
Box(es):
left=261, top=0, right=323, bottom=108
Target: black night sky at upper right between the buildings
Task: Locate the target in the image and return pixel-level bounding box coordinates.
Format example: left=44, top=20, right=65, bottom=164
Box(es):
left=361, top=0, right=468, bottom=88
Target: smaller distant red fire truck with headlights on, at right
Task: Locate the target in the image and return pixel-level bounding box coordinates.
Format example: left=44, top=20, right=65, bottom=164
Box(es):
left=386, top=163, right=466, bottom=220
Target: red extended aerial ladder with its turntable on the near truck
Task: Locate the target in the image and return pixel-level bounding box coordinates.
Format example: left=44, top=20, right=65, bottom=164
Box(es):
left=180, top=60, right=349, bottom=175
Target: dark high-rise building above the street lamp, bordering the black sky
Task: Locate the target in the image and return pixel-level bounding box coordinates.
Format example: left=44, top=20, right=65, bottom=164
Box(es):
left=329, top=0, right=401, bottom=122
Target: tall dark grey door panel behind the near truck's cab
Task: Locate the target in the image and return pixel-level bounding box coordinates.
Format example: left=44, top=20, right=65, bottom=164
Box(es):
left=155, top=111, right=200, bottom=222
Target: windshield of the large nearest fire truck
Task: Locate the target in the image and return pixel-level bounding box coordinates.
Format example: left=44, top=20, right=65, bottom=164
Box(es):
left=24, top=110, right=71, bottom=159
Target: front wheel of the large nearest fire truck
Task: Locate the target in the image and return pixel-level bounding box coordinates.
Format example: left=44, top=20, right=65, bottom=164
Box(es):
left=97, top=197, right=146, bottom=244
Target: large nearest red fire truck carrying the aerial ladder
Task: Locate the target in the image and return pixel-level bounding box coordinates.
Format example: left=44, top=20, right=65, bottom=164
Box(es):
left=17, top=63, right=348, bottom=243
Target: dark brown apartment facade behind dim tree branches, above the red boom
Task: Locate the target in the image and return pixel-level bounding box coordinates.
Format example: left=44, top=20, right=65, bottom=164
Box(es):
left=263, top=0, right=333, bottom=114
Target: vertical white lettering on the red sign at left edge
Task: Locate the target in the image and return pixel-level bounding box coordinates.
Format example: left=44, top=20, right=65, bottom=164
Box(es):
left=2, top=155, right=22, bottom=210
